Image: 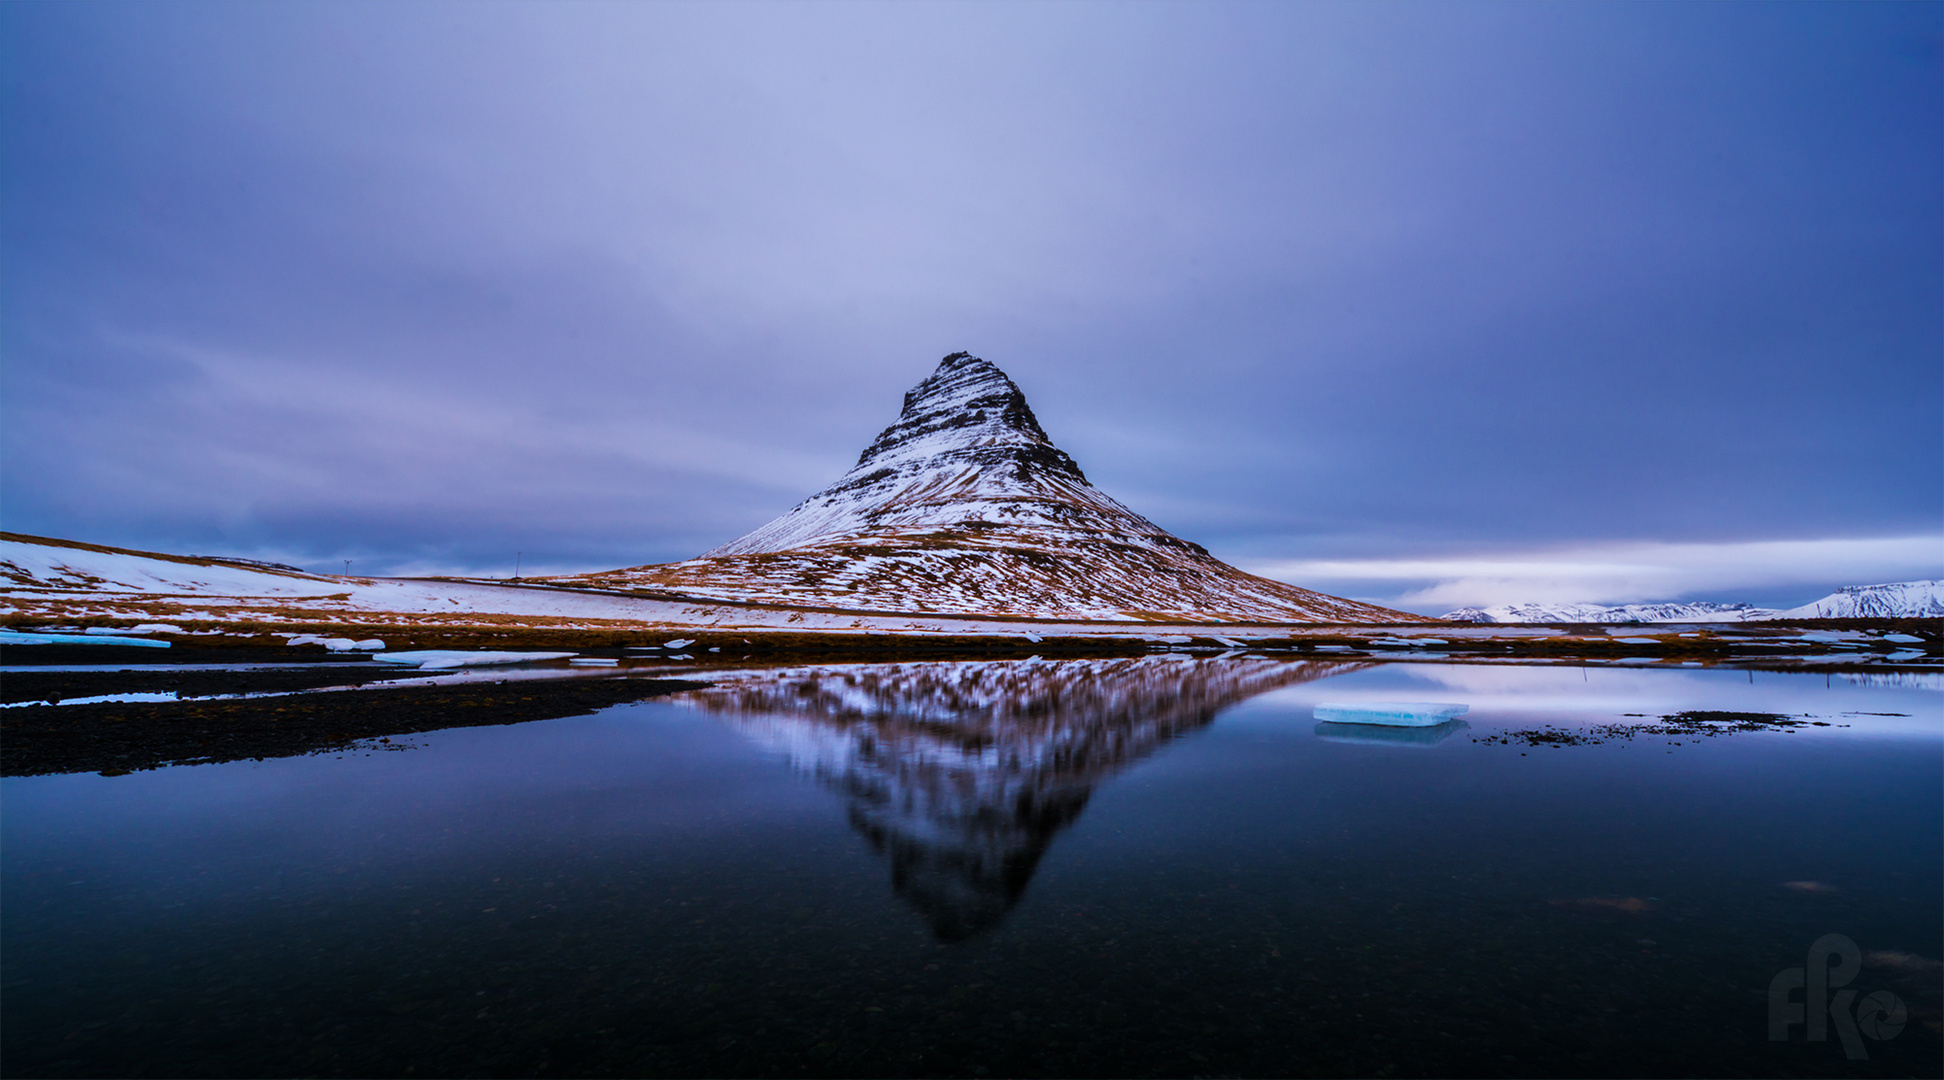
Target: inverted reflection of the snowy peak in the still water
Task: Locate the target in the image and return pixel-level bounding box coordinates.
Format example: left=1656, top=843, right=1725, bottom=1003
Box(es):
left=678, top=655, right=1369, bottom=940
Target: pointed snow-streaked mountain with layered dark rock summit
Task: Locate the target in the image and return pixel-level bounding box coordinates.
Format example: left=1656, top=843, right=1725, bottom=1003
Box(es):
left=554, top=352, right=1419, bottom=622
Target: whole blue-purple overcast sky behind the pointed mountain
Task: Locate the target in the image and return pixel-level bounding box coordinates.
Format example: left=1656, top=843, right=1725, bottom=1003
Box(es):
left=0, top=2, right=1944, bottom=612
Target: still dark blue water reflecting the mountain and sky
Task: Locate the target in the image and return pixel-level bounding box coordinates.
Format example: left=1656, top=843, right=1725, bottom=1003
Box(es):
left=0, top=657, right=1944, bottom=1076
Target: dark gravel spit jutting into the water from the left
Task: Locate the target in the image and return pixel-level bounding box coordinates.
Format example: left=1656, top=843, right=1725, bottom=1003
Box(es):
left=0, top=670, right=706, bottom=777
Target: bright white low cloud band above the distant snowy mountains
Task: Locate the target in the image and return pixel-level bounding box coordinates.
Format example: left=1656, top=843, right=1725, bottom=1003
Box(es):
left=1244, top=534, right=1944, bottom=616
